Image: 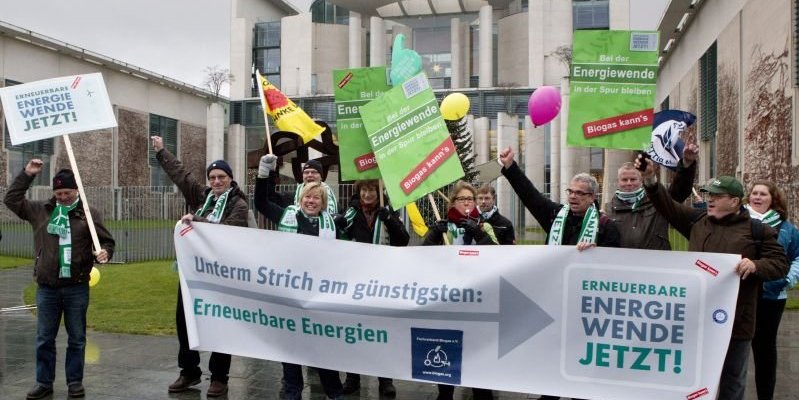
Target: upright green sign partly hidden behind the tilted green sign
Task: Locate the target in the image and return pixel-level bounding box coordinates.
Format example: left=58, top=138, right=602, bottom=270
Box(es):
left=333, top=66, right=391, bottom=181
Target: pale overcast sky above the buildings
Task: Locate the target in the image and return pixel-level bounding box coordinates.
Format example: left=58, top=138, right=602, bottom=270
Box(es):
left=0, top=0, right=668, bottom=94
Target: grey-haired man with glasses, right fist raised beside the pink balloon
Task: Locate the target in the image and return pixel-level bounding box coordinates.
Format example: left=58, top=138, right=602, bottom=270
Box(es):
left=499, top=147, right=621, bottom=250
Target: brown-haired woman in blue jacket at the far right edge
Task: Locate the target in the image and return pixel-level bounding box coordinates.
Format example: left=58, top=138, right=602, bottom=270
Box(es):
left=744, top=181, right=799, bottom=400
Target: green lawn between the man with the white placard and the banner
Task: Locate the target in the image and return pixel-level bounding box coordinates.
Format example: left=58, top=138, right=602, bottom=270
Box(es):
left=24, top=261, right=178, bottom=335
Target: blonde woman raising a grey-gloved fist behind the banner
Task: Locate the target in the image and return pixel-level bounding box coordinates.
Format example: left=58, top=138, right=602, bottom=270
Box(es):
left=255, top=154, right=343, bottom=400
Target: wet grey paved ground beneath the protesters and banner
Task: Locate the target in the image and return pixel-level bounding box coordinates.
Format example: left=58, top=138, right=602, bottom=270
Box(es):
left=0, top=268, right=799, bottom=400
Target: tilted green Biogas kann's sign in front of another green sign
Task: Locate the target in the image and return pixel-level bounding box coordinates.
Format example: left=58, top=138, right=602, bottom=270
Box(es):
left=360, top=73, right=463, bottom=208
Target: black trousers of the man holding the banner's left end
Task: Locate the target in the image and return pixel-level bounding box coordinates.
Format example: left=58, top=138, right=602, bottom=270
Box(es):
left=175, top=286, right=230, bottom=383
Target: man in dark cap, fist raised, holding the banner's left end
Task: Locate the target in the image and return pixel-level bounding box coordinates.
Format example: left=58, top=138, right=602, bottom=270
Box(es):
left=152, top=136, right=248, bottom=397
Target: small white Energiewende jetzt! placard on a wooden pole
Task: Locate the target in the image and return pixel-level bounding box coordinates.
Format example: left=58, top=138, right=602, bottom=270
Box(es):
left=0, top=72, right=117, bottom=145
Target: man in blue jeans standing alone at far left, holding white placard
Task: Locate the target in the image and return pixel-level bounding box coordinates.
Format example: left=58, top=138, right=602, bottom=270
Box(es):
left=5, top=159, right=114, bottom=399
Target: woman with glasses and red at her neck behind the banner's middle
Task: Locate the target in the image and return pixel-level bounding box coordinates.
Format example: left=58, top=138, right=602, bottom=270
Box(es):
left=422, top=181, right=499, bottom=400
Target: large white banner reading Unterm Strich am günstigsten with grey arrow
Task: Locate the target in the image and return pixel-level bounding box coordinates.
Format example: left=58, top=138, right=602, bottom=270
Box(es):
left=175, top=223, right=739, bottom=400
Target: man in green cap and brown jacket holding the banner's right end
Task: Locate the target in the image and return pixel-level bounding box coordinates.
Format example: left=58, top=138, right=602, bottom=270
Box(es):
left=636, top=160, right=788, bottom=400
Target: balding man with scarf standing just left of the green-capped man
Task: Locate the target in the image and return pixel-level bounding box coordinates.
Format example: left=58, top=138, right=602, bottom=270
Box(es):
left=607, top=144, right=698, bottom=250
